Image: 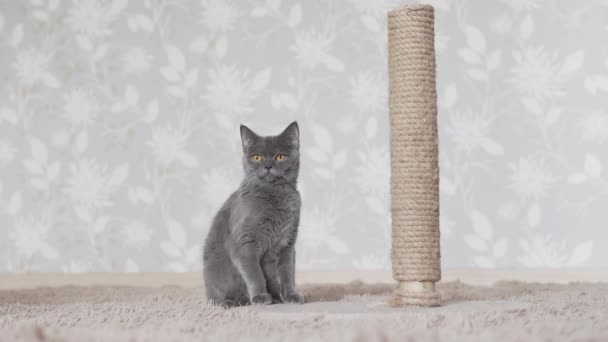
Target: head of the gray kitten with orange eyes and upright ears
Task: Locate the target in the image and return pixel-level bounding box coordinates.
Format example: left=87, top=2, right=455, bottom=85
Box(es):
left=241, top=121, right=300, bottom=184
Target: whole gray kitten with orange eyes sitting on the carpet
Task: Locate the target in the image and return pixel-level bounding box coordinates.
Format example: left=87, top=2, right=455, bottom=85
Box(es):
left=203, top=122, right=304, bottom=307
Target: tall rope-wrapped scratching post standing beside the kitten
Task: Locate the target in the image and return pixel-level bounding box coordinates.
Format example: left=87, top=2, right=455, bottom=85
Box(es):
left=388, top=5, right=441, bottom=306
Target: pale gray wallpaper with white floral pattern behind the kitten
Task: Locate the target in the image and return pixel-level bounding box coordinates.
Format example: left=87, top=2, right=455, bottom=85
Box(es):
left=0, top=0, right=608, bottom=272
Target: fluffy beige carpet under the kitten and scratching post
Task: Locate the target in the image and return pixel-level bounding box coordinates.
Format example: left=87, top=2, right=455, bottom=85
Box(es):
left=0, top=282, right=608, bottom=342
